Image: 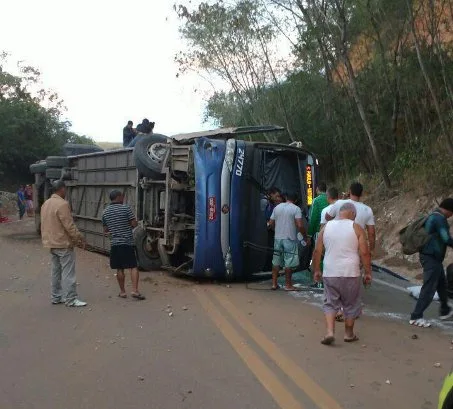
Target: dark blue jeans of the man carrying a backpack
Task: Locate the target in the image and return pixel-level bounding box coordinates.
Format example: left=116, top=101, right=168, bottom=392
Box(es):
left=411, top=254, right=450, bottom=320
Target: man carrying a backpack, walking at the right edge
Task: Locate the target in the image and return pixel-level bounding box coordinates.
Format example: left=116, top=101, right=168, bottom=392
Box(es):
left=406, top=198, right=453, bottom=328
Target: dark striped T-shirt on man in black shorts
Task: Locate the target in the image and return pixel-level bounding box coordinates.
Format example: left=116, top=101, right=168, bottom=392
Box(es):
left=102, top=203, right=135, bottom=246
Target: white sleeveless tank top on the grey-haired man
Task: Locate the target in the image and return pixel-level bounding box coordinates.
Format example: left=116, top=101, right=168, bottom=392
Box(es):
left=323, top=219, right=360, bottom=277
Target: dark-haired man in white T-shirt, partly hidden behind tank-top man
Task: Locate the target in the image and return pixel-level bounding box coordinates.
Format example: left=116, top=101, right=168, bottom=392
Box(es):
left=326, top=182, right=376, bottom=257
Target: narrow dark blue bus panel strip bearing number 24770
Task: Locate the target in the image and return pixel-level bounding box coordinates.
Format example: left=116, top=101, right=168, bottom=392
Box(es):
left=230, top=140, right=248, bottom=279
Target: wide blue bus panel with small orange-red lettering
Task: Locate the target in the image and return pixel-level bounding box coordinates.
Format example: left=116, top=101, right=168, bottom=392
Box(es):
left=192, top=138, right=226, bottom=278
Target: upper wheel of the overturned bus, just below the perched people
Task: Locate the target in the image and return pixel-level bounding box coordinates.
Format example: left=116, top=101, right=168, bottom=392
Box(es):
left=134, top=134, right=168, bottom=180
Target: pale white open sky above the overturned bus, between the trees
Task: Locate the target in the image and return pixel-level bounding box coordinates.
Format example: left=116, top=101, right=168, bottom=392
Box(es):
left=0, top=0, right=213, bottom=142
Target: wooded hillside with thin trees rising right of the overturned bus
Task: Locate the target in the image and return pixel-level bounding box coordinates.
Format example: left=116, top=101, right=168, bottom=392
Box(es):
left=175, top=0, right=453, bottom=189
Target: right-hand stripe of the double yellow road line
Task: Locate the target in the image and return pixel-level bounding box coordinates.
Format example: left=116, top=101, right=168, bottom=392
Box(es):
left=210, top=289, right=342, bottom=409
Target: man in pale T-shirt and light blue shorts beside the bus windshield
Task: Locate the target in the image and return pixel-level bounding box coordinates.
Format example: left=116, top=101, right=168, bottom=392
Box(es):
left=269, top=193, right=307, bottom=291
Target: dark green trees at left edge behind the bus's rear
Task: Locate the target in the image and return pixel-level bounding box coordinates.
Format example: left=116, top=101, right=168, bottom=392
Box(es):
left=0, top=53, right=94, bottom=187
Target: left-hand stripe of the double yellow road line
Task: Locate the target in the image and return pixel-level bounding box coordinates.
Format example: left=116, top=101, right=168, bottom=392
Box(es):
left=195, top=291, right=303, bottom=409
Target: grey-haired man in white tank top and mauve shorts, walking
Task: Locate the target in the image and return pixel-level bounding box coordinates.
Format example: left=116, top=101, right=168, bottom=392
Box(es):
left=313, top=203, right=371, bottom=345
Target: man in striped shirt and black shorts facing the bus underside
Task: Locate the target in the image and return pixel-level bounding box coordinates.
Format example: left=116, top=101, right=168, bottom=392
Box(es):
left=102, top=190, right=145, bottom=300
